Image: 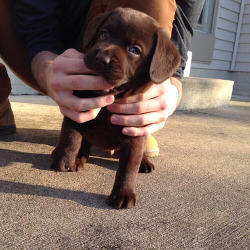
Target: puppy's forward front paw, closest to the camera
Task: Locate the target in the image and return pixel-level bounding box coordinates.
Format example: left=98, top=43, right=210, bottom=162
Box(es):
left=108, top=191, right=136, bottom=209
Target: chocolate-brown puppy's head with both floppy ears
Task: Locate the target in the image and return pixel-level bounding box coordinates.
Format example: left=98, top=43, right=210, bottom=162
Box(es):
left=82, top=8, right=180, bottom=95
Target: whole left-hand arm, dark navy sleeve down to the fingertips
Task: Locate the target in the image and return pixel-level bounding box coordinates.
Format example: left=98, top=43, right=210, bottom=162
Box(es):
left=12, top=0, right=114, bottom=123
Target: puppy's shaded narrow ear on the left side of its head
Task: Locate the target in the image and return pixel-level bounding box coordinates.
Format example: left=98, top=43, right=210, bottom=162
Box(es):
left=82, top=11, right=112, bottom=50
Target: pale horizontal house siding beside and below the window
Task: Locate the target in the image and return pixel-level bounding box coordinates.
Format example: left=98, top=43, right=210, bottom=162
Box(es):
left=191, top=0, right=250, bottom=96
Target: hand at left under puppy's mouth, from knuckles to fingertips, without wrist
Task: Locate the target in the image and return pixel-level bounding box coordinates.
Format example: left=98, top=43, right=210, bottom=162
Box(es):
left=50, top=49, right=114, bottom=123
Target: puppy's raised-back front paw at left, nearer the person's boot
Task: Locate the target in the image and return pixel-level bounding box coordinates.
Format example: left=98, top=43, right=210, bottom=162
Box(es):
left=50, top=149, right=78, bottom=172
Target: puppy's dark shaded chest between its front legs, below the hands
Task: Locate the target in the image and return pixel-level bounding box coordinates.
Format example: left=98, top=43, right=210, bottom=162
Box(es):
left=83, top=108, right=122, bottom=150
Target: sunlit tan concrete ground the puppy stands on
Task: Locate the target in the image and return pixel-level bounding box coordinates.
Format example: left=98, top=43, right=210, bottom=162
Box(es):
left=0, top=97, right=250, bottom=250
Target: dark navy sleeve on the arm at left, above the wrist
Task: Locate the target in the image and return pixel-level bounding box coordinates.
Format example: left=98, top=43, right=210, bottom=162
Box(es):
left=11, top=0, right=65, bottom=65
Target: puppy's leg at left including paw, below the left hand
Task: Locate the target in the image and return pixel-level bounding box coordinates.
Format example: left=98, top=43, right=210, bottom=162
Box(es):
left=50, top=117, right=82, bottom=172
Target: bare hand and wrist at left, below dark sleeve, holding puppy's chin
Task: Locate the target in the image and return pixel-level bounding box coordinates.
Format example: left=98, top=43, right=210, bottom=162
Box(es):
left=31, top=49, right=114, bottom=123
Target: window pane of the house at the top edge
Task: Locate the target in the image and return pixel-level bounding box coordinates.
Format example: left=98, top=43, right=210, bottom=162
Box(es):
left=196, top=0, right=215, bottom=33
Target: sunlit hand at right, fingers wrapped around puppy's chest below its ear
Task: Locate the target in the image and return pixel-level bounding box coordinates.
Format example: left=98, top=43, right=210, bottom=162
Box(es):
left=107, top=79, right=179, bottom=136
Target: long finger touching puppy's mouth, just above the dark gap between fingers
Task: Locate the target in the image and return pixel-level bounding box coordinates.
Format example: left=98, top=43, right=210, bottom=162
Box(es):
left=50, top=75, right=113, bottom=90
